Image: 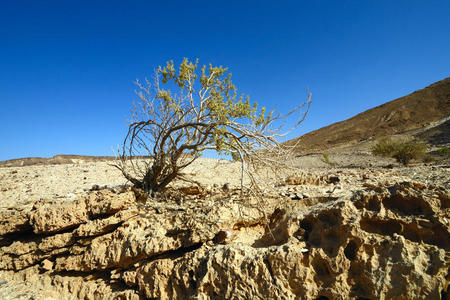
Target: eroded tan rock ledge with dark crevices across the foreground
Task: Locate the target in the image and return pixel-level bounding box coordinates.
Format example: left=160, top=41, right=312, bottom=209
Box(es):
left=0, top=178, right=450, bottom=299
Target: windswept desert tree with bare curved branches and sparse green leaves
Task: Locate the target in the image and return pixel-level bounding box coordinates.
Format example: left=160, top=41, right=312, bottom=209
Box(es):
left=115, top=59, right=311, bottom=193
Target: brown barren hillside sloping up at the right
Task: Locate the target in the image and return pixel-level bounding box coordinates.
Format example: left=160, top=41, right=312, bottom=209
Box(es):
left=289, top=77, right=450, bottom=154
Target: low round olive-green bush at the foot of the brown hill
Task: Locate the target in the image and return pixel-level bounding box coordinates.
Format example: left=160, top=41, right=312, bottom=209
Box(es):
left=372, top=138, right=427, bottom=166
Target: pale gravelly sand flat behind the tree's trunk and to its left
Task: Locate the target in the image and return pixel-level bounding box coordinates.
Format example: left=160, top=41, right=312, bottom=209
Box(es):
left=0, top=158, right=244, bottom=207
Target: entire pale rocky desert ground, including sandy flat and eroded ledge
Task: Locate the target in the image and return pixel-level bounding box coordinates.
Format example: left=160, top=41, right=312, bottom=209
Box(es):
left=0, top=151, right=450, bottom=299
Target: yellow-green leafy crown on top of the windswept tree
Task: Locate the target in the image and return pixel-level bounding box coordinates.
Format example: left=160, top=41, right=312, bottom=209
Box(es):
left=155, top=58, right=273, bottom=154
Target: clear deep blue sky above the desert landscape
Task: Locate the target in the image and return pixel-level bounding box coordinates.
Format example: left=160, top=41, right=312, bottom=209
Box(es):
left=0, top=0, right=450, bottom=160
